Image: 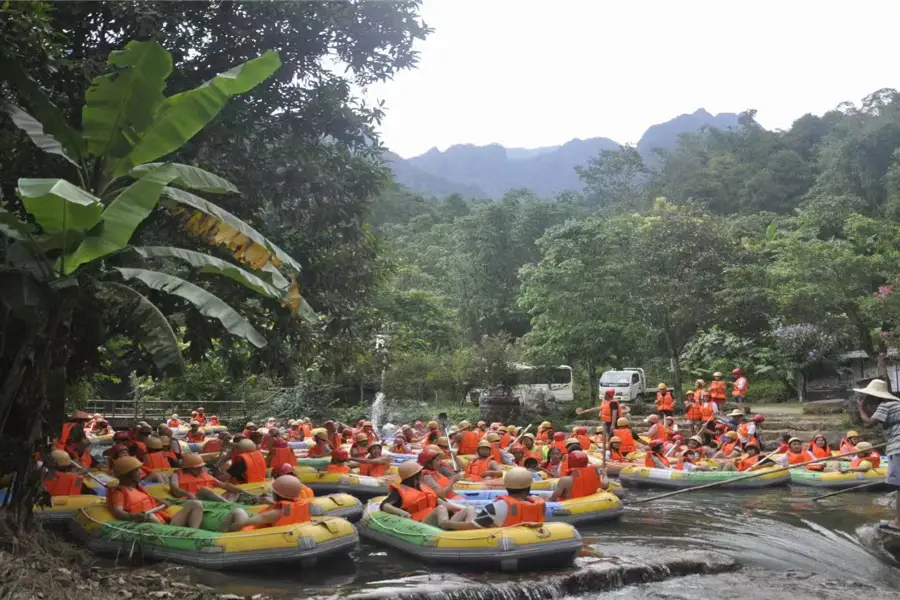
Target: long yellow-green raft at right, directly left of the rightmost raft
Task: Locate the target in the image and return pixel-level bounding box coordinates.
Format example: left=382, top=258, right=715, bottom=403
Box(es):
left=619, top=467, right=791, bottom=490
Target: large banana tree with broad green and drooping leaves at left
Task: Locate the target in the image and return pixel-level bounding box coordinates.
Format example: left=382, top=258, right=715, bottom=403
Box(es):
left=0, top=41, right=317, bottom=520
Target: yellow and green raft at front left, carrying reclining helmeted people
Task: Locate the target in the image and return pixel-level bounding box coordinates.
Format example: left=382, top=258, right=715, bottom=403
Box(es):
left=71, top=506, right=359, bottom=569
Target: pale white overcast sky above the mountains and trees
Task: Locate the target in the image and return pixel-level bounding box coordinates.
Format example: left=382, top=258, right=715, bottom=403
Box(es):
left=366, top=0, right=900, bottom=158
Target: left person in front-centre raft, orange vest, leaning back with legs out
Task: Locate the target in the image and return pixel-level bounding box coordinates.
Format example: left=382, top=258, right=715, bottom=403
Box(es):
left=381, top=460, right=478, bottom=530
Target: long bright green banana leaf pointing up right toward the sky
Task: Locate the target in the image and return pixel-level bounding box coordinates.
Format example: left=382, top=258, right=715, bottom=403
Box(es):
left=121, top=50, right=281, bottom=175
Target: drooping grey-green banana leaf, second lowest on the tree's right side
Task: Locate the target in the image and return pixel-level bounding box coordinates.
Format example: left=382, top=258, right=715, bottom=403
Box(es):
left=116, top=267, right=266, bottom=348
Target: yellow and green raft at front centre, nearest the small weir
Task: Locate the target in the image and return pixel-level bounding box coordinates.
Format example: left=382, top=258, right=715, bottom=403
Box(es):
left=357, top=501, right=581, bottom=571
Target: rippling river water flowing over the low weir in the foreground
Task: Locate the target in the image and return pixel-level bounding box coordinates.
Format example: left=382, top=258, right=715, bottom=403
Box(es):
left=185, top=487, right=900, bottom=600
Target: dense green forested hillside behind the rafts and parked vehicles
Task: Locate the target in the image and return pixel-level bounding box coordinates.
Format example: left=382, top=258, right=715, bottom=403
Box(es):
left=375, top=90, right=900, bottom=406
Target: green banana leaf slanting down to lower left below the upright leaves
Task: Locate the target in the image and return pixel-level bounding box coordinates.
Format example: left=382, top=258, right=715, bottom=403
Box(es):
left=63, top=163, right=178, bottom=274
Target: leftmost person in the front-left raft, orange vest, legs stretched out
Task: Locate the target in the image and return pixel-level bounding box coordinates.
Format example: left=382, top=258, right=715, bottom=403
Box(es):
left=106, top=456, right=203, bottom=529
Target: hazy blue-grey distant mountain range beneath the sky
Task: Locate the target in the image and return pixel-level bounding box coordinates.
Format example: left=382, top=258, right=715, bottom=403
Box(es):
left=385, top=108, right=738, bottom=198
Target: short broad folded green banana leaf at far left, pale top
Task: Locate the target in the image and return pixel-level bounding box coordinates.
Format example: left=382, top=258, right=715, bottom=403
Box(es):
left=16, top=178, right=103, bottom=233
